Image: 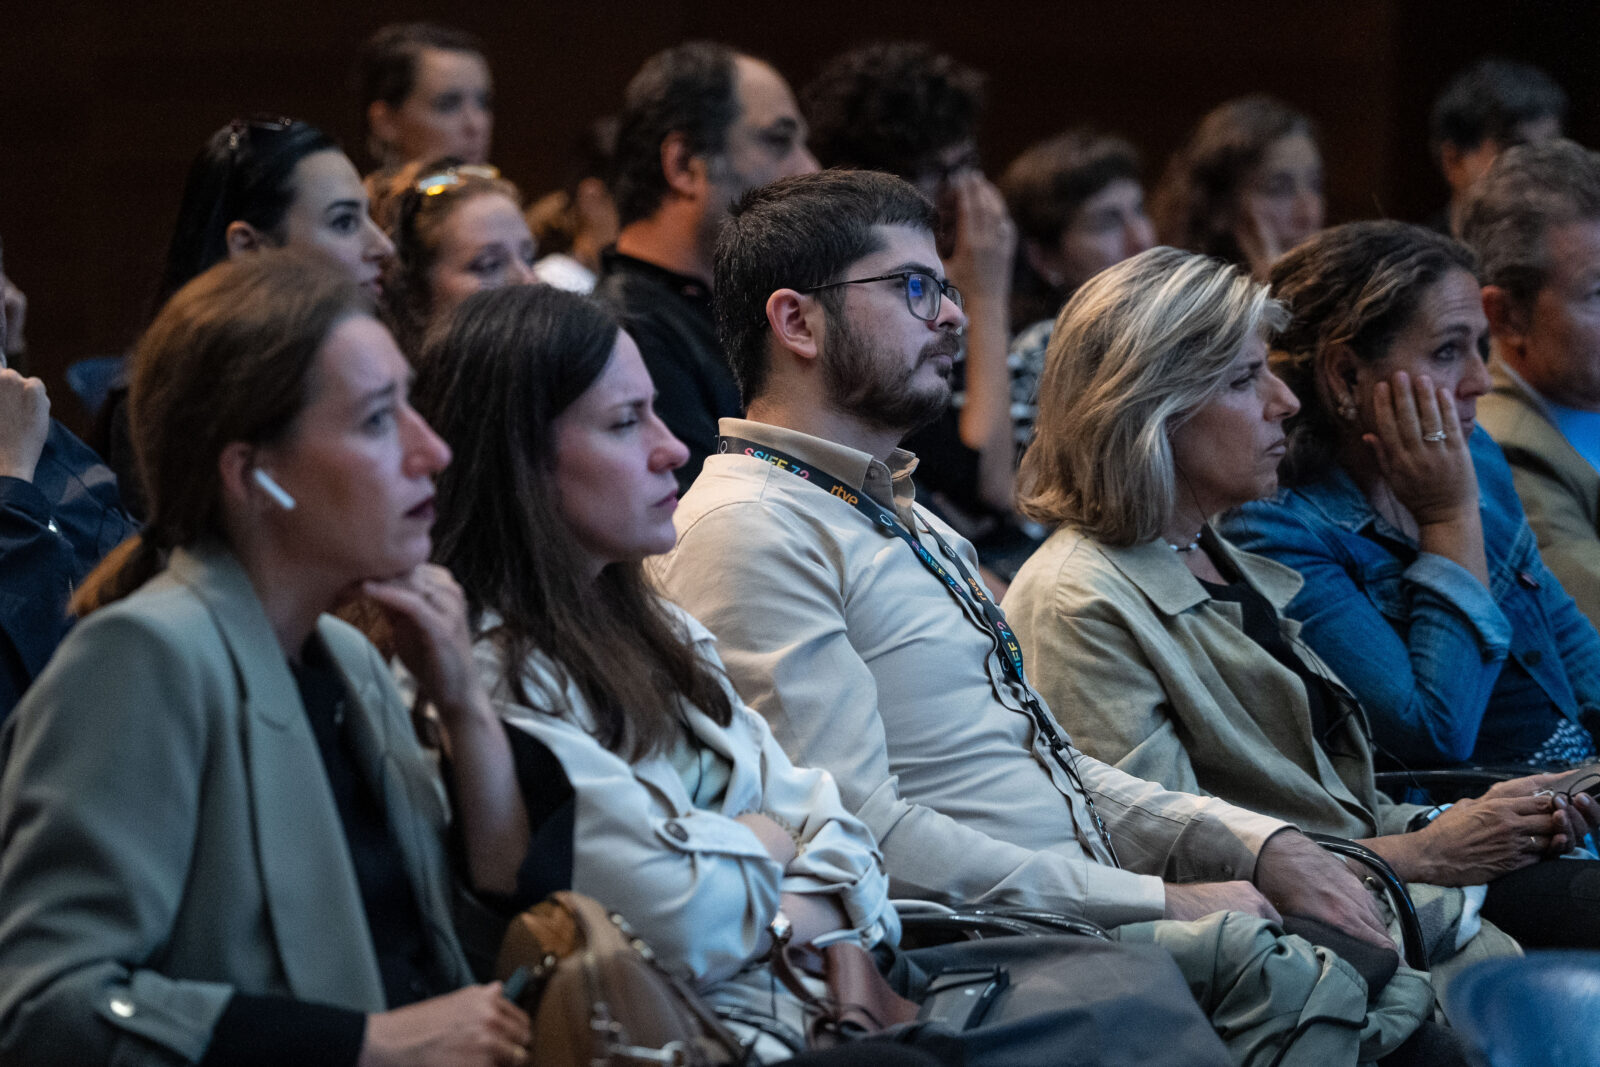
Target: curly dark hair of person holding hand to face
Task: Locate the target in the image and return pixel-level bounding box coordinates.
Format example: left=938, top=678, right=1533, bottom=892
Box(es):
left=800, top=42, right=984, bottom=179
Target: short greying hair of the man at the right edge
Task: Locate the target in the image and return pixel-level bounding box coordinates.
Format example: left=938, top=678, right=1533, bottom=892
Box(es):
left=1461, top=141, right=1600, bottom=307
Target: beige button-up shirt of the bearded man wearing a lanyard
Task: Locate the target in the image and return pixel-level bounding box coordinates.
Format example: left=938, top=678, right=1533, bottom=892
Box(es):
left=653, top=419, right=1285, bottom=926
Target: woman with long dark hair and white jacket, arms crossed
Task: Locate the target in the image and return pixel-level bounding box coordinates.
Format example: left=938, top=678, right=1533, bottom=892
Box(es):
left=418, top=290, right=1401, bottom=1065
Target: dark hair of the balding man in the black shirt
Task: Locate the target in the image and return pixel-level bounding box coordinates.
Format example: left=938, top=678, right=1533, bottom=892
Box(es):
left=611, top=40, right=739, bottom=226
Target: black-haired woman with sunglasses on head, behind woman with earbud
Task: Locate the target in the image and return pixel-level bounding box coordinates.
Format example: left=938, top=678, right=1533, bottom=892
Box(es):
left=98, top=118, right=394, bottom=515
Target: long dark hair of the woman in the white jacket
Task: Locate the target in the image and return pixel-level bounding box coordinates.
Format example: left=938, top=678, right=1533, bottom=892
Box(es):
left=413, top=286, right=733, bottom=761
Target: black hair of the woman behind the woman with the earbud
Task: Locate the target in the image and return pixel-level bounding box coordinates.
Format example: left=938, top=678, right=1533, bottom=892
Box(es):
left=157, top=117, right=339, bottom=307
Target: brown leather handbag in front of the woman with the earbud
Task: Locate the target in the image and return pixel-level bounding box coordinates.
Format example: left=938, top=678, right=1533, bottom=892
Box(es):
left=494, top=893, right=752, bottom=1067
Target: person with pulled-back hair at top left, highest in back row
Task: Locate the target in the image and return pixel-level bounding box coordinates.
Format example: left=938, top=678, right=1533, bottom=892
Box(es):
left=352, top=22, right=494, bottom=171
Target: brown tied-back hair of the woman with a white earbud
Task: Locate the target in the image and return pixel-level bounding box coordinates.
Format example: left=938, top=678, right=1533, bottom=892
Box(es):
left=72, top=250, right=373, bottom=616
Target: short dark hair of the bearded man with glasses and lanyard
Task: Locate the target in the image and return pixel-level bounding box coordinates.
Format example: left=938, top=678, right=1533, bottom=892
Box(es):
left=714, top=170, right=938, bottom=406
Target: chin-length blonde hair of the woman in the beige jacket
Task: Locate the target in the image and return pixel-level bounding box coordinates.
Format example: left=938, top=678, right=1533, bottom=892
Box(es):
left=1019, top=248, right=1288, bottom=545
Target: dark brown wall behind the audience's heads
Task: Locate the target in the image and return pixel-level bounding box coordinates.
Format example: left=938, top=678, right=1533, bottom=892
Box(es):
left=0, top=0, right=1600, bottom=435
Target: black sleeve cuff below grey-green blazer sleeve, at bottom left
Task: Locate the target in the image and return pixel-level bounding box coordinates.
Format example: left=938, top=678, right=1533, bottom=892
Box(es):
left=200, top=993, right=366, bottom=1067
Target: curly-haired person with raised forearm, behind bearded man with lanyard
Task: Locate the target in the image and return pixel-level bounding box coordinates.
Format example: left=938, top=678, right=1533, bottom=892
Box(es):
left=800, top=42, right=1032, bottom=543
